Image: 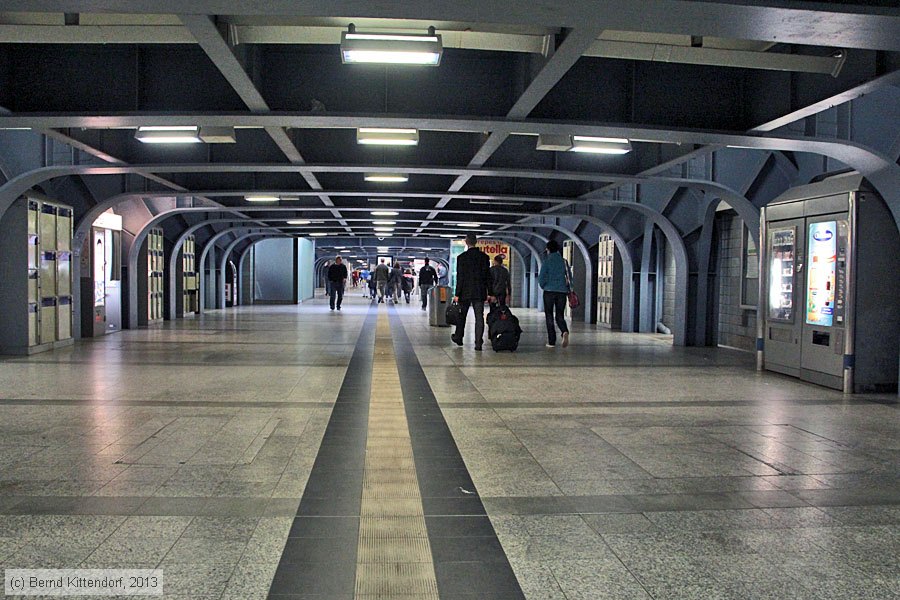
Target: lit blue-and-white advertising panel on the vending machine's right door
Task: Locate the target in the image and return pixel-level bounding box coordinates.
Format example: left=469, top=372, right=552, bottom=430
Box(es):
left=806, top=221, right=837, bottom=327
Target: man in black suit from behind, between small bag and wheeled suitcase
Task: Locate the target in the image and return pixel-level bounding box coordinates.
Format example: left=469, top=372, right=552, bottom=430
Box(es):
left=450, top=233, right=493, bottom=351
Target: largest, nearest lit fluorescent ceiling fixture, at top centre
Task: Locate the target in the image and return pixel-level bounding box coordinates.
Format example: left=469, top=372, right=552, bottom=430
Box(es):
left=341, top=23, right=443, bottom=67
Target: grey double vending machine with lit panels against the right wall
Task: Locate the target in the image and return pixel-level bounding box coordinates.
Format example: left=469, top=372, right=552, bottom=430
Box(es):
left=757, top=174, right=900, bottom=393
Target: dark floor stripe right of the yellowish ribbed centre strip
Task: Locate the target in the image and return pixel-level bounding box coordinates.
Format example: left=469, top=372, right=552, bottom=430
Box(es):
left=389, top=309, right=525, bottom=600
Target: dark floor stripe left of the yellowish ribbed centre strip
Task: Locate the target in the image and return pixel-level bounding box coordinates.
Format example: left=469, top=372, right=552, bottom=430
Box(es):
left=269, top=308, right=378, bottom=600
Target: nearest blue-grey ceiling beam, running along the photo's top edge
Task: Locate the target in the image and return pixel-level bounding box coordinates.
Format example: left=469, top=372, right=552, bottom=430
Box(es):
left=4, top=0, right=900, bottom=51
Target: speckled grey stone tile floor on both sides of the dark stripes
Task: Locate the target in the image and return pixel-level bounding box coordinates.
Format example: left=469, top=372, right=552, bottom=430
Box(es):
left=0, top=297, right=900, bottom=600
